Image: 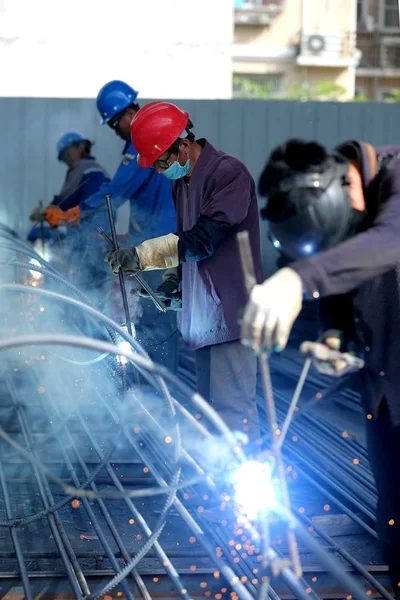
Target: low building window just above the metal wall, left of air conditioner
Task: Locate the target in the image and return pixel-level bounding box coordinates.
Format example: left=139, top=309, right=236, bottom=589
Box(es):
left=232, top=73, right=283, bottom=100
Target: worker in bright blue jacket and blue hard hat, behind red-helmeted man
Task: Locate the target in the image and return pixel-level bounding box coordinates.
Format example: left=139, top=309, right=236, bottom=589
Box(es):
left=42, top=81, right=177, bottom=370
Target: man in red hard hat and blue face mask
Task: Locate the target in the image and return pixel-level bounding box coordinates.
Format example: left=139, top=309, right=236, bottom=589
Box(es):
left=106, top=102, right=262, bottom=442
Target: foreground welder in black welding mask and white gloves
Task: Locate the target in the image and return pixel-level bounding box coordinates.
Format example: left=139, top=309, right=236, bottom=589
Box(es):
left=242, top=140, right=400, bottom=597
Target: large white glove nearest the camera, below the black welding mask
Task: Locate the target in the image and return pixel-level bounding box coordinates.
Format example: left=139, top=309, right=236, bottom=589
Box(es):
left=241, top=267, right=303, bottom=354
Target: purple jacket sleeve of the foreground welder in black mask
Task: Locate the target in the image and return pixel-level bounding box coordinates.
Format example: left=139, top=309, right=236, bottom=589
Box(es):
left=290, top=167, right=400, bottom=297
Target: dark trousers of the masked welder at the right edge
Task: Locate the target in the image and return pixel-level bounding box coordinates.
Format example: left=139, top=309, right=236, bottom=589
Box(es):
left=367, top=400, right=400, bottom=600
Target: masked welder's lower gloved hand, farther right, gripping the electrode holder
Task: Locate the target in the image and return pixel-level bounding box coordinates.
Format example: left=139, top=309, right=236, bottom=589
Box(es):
left=310, top=329, right=362, bottom=377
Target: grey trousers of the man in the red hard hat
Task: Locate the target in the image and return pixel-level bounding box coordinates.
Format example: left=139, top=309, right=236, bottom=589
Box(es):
left=195, top=340, right=260, bottom=450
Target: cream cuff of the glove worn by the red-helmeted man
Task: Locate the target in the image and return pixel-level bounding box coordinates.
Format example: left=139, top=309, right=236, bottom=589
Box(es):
left=136, top=233, right=179, bottom=271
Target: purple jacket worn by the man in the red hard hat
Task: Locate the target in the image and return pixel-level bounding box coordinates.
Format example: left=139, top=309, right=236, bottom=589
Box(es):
left=174, top=140, right=262, bottom=350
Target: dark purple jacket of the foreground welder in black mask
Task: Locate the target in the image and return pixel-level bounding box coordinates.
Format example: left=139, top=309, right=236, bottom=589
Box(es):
left=290, top=142, right=400, bottom=426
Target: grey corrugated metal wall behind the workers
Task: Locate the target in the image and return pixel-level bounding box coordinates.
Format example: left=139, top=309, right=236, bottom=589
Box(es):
left=0, top=98, right=400, bottom=270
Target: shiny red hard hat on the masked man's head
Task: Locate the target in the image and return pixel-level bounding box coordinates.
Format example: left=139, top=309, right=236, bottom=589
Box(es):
left=131, top=101, right=189, bottom=167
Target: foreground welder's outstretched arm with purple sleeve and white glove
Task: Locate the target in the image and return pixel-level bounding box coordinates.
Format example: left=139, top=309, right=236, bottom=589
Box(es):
left=242, top=169, right=400, bottom=352
